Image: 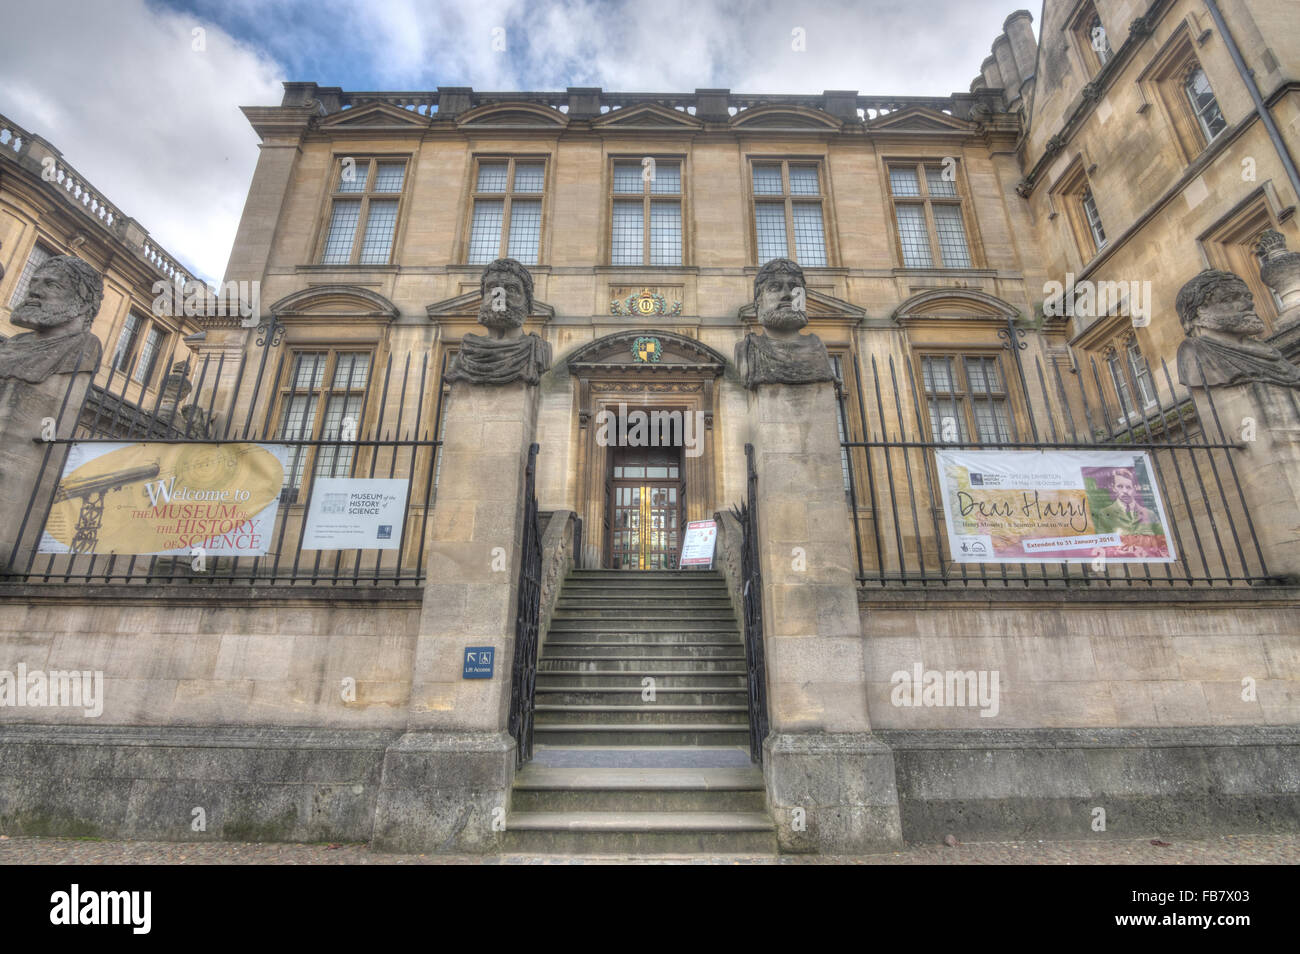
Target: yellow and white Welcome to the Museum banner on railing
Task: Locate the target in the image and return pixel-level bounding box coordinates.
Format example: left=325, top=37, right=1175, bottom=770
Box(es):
left=40, top=442, right=289, bottom=556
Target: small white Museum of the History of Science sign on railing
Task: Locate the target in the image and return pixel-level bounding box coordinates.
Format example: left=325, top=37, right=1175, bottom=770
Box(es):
left=303, top=477, right=407, bottom=550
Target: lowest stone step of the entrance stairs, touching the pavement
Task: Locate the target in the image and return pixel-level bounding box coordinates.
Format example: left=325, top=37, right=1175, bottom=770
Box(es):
left=503, top=811, right=776, bottom=854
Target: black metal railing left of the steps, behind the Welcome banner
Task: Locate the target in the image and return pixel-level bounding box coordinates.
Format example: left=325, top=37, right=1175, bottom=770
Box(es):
left=0, top=340, right=442, bottom=586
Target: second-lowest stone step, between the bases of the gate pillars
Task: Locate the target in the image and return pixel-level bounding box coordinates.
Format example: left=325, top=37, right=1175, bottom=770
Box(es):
left=510, top=763, right=767, bottom=814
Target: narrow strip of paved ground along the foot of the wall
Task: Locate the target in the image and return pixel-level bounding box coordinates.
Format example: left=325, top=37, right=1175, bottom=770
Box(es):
left=0, top=834, right=1300, bottom=864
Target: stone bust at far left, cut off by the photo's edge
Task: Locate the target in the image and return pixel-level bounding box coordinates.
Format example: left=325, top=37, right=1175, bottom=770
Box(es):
left=0, top=255, right=104, bottom=385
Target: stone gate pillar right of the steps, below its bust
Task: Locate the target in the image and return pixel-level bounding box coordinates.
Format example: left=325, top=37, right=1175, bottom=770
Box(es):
left=750, top=382, right=902, bottom=854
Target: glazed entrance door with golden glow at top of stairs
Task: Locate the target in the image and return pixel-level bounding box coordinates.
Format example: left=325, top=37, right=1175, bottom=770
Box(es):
left=607, top=447, right=685, bottom=569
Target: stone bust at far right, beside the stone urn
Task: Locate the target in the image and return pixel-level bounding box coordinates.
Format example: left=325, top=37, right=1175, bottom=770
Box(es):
left=1174, top=269, right=1300, bottom=387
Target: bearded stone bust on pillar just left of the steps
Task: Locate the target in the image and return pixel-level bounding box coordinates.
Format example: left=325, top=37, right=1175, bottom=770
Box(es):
left=447, top=259, right=551, bottom=385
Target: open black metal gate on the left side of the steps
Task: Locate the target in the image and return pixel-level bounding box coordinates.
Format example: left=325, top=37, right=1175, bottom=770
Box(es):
left=508, top=445, right=542, bottom=766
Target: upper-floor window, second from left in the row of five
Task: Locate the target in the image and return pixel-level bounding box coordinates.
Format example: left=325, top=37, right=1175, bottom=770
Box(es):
left=465, top=159, right=546, bottom=265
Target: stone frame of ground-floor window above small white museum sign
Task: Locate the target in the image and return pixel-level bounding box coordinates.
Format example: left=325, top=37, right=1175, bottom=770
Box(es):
left=268, top=348, right=380, bottom=506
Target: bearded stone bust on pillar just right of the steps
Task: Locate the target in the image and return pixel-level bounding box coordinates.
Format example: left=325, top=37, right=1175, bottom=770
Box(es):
left=736, top=259, right=835, bottom=390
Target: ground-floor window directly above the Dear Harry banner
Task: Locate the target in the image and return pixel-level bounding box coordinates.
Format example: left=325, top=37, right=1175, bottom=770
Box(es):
left=920, top=355, right=1014, bottom=443
